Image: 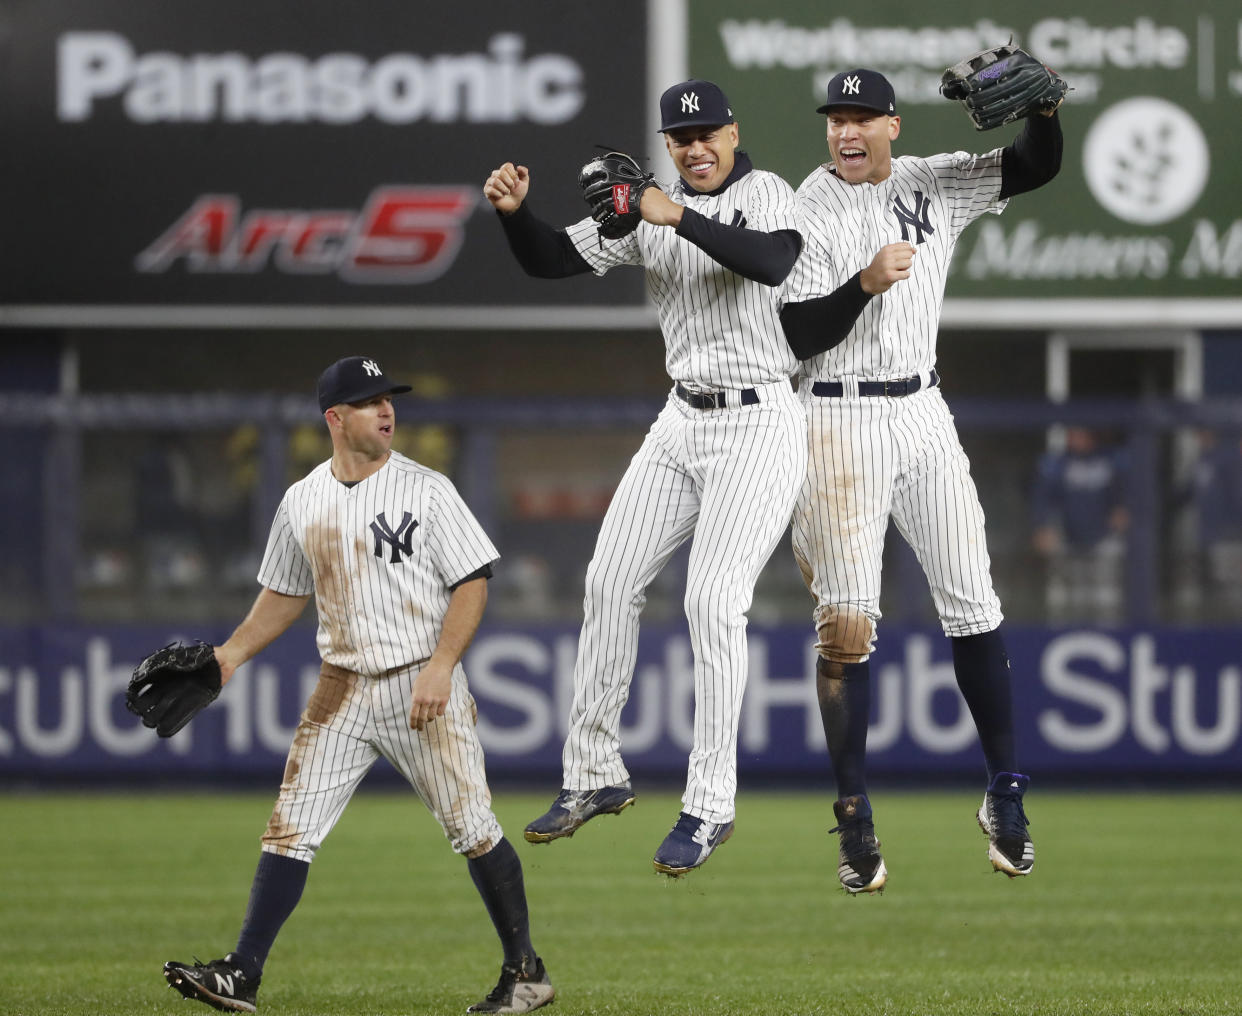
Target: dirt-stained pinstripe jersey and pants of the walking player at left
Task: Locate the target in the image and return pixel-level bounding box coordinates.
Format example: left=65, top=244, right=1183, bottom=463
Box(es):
left=258, top=452, right=502, bottom=861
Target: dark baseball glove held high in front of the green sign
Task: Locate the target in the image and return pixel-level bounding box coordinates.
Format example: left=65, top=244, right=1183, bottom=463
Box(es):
left=940, top=43, right=1069, bottom=130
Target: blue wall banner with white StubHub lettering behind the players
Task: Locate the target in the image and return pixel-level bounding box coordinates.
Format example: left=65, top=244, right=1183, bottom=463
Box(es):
left=0, top=626, right=1242, bottom=784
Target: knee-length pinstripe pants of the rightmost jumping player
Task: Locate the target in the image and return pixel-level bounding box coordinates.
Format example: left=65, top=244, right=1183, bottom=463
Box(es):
left=794, top=383, right=1002, bottom=655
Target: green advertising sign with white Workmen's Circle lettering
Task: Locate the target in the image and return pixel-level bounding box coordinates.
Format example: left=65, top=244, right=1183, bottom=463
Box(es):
left=688, top=0, right=1242, bottom=316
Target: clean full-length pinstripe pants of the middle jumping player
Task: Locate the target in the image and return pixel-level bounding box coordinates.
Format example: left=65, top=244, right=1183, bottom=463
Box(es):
left=563, top=381, right=806, bottom=822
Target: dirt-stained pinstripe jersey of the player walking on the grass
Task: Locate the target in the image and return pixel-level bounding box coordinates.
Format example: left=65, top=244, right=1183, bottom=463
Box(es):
left=258, top=452, right=499, bottom=676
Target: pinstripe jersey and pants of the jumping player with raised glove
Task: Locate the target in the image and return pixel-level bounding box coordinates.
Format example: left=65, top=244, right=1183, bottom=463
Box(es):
left=785, top=149, right=1005, bottom=662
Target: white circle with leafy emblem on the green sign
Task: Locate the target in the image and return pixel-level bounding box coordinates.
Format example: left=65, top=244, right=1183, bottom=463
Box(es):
left=1083, top=96, right=1211, bottom=226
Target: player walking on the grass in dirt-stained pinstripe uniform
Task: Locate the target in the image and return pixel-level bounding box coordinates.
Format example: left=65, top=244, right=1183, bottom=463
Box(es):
left=164, top=356, right=554, bottom=1012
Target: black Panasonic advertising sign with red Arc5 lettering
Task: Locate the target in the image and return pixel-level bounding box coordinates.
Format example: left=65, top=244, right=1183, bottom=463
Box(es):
left=0, top=0, right=650, bottom=316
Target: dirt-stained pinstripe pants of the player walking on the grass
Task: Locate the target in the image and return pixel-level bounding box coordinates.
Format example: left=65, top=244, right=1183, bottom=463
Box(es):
left=262, top=663, right=503, bottom=862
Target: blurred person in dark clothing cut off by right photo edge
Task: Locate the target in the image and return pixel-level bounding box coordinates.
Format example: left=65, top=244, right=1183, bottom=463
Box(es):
left=1185, top=427, right=1242, bottom=610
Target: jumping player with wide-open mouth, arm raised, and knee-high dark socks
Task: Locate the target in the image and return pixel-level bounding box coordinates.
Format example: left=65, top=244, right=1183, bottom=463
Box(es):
left=782, top=68, right=1062, bottom=893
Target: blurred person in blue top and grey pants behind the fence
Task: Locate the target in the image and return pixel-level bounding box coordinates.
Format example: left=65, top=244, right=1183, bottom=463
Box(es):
left=1032, top=426, right=1130, bottom=621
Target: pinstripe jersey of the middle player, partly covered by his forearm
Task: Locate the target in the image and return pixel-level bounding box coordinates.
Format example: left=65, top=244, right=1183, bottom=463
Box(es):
left=565, top=169, right=800, bottom=389
